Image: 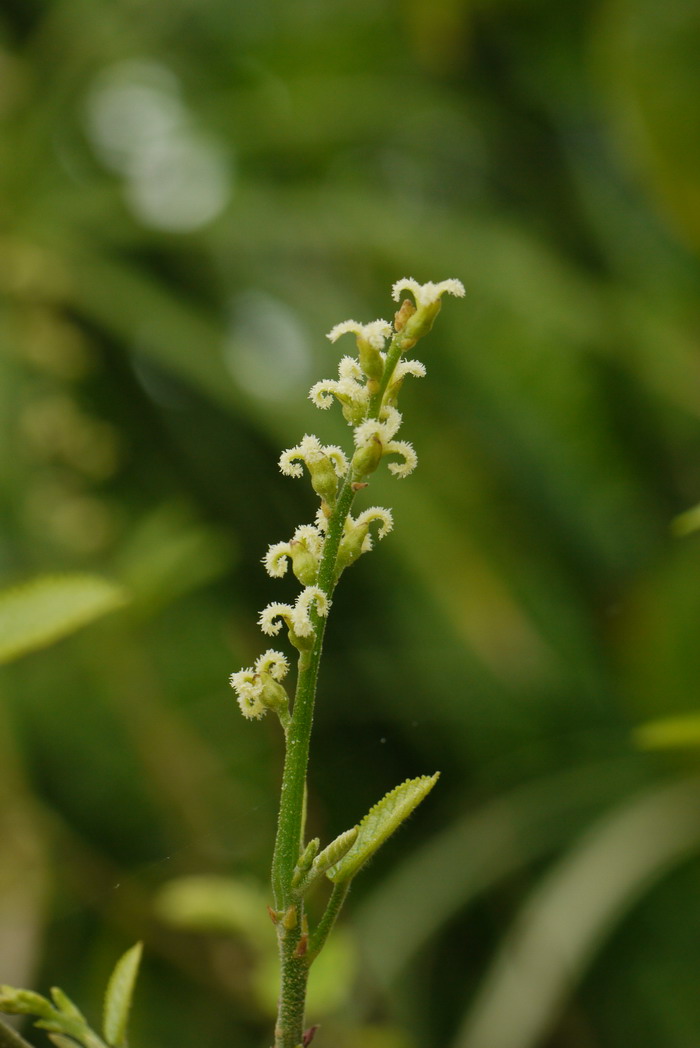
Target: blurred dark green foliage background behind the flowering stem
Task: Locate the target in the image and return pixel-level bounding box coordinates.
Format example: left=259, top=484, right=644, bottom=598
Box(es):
left=0, top=0, right=700, bottom=1048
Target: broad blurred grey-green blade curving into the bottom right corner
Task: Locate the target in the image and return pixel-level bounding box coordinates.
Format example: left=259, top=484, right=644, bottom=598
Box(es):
left=453, top=778, right=700, bottom=1048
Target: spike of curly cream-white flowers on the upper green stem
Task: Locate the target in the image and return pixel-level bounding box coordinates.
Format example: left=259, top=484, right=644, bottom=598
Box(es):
left=231, top=278, right=464, bottom=730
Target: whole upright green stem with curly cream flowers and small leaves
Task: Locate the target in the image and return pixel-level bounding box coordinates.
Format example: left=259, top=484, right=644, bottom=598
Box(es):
left=231, top=279, right=464, bottom=1048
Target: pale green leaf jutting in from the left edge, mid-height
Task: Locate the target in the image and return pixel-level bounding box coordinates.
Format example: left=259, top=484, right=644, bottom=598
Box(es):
left=0, top=575, right=126, bottom=663
